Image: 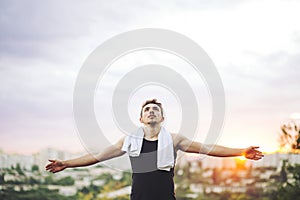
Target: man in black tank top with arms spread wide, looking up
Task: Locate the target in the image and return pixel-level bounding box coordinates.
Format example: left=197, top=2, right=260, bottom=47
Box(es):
left=46, top=99, right=263, bottom=200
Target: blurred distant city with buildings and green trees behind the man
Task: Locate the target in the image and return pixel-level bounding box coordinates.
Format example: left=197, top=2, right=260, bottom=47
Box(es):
left=0, top=148, right=300, bottom=199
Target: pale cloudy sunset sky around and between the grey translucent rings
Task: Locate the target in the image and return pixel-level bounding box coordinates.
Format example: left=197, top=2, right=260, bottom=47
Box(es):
left=0, top=0, right=300, bottom=154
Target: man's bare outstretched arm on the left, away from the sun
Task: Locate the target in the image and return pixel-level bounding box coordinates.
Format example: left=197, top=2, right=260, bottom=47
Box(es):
left=46, top=138, right=125, bottom=173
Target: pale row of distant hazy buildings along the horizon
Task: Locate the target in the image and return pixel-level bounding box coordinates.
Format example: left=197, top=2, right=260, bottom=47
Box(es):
left=0, top=148, right=300, bottom=170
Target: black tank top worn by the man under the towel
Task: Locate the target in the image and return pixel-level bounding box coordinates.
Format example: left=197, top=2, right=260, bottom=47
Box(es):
left=130, top=139, right=176, bottom=200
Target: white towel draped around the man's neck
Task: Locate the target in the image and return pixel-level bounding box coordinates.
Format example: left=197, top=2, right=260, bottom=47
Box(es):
left=122, top=127, right=174, bottom=171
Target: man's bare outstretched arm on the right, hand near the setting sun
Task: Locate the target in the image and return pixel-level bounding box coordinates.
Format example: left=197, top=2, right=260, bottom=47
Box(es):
left=176, top=135, right=264, bottom=160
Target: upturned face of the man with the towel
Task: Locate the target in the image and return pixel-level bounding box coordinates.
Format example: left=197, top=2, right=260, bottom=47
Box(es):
left=140, top=103, right=164, bottom=124
